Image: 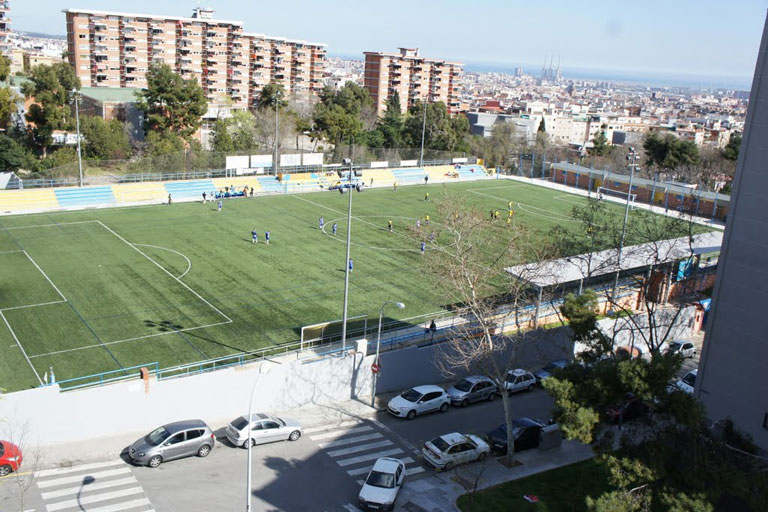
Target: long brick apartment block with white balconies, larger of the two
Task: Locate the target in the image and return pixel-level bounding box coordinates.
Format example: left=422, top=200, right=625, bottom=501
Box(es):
left=66, top=7, right=326, bottom=108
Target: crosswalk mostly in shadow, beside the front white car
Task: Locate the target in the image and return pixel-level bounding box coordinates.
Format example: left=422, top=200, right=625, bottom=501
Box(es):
left=304, top=420, right=424, bottom=485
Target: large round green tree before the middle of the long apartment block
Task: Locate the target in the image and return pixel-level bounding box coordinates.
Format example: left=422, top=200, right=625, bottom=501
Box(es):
left=135, top=64, right=208, bottom=141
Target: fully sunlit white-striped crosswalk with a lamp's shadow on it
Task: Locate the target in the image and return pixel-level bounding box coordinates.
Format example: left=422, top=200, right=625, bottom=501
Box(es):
left=35, top=459, right=152, bottom=512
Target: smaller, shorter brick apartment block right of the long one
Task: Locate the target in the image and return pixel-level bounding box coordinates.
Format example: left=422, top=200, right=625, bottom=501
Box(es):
left=363, top=48, right=462, bottom=115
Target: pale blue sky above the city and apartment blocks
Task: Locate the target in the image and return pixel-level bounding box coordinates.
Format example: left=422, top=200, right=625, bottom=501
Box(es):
left=11, top=0, right=768, bottom=87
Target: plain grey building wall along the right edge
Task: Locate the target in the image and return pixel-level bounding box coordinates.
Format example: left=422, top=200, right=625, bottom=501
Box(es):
left=695, top=14, right=768, bottom=450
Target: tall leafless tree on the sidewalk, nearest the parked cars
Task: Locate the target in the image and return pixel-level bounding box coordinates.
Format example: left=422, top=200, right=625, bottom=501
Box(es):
left=425, top=194, right=544, bottom=465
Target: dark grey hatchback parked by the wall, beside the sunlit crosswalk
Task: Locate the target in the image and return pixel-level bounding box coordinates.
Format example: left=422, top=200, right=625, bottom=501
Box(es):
left=128, top=420, right=216, bottom=468
